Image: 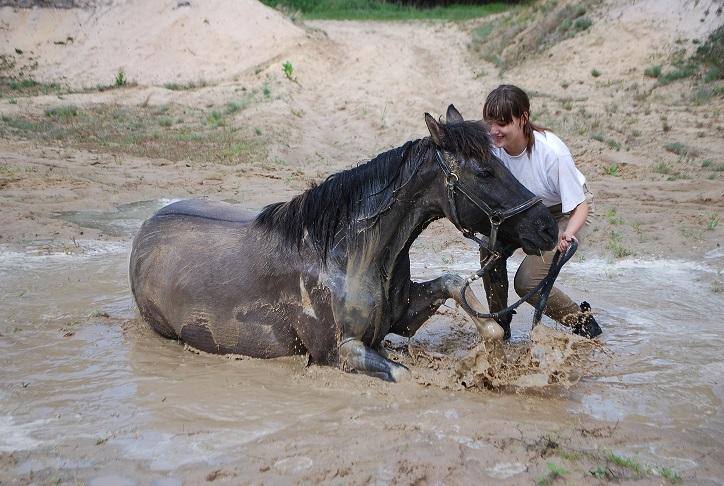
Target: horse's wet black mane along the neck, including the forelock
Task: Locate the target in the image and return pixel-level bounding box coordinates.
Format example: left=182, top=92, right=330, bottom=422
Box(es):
left=254, top=121, right=491, bottom=261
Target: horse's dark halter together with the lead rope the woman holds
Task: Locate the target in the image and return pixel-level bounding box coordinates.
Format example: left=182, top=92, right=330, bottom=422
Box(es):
left=435, top=149, right=578, bottom=327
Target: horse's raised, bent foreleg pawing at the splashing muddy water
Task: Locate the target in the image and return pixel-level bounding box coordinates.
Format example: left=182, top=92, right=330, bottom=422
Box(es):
left=390, top=273, right=504, bottom=339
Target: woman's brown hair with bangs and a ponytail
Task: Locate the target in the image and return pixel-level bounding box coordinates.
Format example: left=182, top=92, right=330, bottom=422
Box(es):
left=483, top=84, right=547, bottom=155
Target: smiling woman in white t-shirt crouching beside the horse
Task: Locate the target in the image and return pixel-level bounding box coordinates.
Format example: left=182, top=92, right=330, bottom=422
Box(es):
left=483, top=84, right=601, bottom=338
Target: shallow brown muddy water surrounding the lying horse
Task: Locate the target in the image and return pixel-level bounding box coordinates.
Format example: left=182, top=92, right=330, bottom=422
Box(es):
left=0, top=202, right=724, bottom=484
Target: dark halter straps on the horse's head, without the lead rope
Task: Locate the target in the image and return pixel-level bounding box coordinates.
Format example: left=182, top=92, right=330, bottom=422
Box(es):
left=435, top=149, right=541, bottom=259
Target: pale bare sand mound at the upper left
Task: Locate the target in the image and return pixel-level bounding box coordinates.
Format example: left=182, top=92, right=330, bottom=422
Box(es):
left=0, top=0, right=304, bottom=86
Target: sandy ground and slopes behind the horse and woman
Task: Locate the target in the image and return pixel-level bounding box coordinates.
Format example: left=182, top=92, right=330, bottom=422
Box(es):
left=0, top=0, right=724, bottom=258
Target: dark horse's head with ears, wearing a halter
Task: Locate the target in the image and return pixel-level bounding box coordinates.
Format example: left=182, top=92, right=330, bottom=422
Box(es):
left=425, top=105, right=558, bottom=254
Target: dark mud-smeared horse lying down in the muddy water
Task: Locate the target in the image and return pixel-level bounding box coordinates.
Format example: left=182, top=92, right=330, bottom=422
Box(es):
left=130, top=105, right=557, bottom=381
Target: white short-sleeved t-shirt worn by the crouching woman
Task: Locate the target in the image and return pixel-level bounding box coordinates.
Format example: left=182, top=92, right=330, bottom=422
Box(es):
left=493, top=130, right=586, bottom=213
